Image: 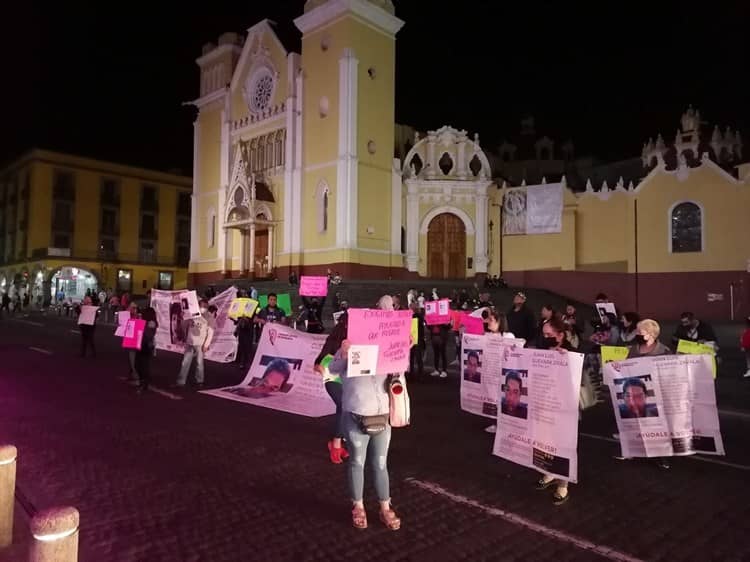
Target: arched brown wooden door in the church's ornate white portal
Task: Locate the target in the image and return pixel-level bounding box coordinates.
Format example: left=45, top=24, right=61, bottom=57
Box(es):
left=427, top=213, right=466, bottom=279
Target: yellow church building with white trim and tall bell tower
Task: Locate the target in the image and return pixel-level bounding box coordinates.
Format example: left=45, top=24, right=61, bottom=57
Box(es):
left=189, top=0, right=750, bottom=319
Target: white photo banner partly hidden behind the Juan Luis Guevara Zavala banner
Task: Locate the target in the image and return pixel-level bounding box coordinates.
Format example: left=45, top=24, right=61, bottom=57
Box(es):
left=461, top=332, right=526, bottom=419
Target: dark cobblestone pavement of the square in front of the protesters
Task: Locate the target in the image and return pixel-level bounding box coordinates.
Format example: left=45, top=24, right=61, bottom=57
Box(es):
left=0, top=317, right=750, bottom=562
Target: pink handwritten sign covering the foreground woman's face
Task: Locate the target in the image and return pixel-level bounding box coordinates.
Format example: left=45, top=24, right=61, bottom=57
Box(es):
left=347, top=308, right=412, bottom=375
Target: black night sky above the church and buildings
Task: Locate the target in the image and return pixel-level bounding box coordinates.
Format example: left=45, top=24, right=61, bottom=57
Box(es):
left=0, top=0, right=750, bottom=174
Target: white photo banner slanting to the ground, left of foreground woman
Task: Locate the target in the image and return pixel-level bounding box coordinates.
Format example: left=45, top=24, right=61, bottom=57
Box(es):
left=203, top=324, right=336, bottom=418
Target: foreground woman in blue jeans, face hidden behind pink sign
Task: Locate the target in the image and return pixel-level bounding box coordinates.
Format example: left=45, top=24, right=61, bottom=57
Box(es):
left=329, top=297, right=401, bottom=531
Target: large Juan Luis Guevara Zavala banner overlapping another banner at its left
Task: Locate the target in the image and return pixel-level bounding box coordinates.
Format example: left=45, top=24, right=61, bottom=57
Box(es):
left=492, top=347, right=583, bottom=482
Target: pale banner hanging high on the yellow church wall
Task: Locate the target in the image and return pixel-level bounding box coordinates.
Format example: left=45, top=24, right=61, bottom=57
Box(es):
left=503, top=183, right=564, bottom=235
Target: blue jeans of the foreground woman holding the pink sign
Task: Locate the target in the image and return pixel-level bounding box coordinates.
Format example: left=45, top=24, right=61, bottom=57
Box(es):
left=342, top=412, right=391, bottom=502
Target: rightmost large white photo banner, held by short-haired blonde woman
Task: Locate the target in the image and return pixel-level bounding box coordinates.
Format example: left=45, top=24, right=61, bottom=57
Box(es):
left=604, top=355, right=724, bottom=458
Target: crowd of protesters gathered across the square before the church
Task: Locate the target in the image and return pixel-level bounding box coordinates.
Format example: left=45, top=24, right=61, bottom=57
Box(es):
left=36, top=280, right=750, bottom=530
